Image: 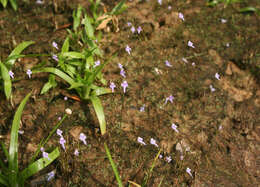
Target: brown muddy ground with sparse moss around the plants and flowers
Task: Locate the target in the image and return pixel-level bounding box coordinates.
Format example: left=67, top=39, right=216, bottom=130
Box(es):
left=0, top=0, right=260, bottom=187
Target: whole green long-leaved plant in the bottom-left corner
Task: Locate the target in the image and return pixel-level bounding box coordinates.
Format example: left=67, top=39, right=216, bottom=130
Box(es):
left=0, top=93, right=60, bottom=187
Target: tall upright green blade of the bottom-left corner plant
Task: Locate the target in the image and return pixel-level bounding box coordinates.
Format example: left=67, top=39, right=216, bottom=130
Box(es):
left=8, top=93, right=31, bottom=184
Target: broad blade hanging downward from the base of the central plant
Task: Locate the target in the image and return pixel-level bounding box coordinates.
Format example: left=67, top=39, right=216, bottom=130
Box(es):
left=90, top=96, right=106, bottom=135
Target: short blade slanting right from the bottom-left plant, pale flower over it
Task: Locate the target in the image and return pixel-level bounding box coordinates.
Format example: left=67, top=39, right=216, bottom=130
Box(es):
left=19, top=148, right=60, bottom=182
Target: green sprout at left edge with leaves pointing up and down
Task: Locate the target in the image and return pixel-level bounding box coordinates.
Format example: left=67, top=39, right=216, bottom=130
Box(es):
left=0, top=41, right=34, bottom=99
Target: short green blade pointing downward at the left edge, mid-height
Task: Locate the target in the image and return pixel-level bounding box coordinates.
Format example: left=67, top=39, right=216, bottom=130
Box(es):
left=0, top=62, right=12, bottom=99
